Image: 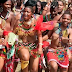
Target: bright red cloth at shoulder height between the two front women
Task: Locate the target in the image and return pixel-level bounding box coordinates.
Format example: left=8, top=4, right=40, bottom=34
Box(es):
left=35, top=15, right=56, bottom=31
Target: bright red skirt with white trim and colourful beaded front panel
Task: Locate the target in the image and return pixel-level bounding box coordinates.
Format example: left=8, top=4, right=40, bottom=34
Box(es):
left=47, top=48, right=69, bottom=68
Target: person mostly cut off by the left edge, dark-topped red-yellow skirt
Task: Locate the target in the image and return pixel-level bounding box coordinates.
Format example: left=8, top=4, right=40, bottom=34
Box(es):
left=0, top=18, right=7, bottom=72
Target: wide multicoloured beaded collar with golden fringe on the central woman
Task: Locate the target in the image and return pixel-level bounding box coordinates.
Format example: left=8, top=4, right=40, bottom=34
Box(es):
left=16, top=18, right=35, bottom=36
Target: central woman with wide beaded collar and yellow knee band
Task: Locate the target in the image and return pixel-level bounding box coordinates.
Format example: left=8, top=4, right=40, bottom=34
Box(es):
left=14, top=6, right=42, bottom=72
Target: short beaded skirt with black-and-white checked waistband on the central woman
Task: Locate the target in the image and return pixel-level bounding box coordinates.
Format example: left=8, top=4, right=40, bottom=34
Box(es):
left=16, top=43, right=40, bottom=58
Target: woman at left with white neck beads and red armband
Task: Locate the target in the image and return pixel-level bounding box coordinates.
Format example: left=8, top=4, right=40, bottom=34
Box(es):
left=0, top=0, right=15, bottom=72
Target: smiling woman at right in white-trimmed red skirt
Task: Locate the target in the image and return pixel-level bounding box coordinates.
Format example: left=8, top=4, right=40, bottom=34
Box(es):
left=43, top=12, right=72, bottom=72
